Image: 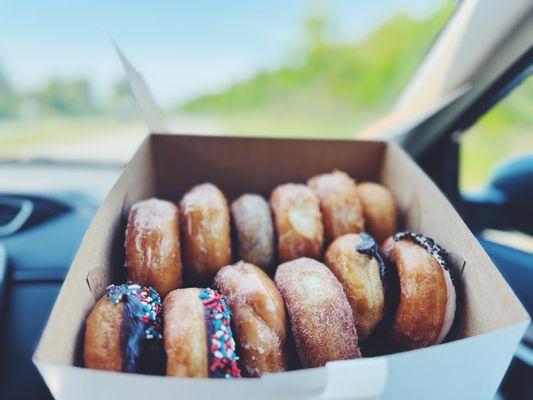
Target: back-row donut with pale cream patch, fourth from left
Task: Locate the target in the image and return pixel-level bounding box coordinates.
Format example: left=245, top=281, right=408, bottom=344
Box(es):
left=270, top=183, right=324, bottom=262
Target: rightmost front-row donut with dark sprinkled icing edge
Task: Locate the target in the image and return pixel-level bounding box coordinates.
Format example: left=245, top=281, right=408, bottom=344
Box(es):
left=383, top=232, right=456, bottom=349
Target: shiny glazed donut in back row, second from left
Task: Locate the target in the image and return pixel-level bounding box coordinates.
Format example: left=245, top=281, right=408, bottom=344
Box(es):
left=180, top=183, right=231, bottom=282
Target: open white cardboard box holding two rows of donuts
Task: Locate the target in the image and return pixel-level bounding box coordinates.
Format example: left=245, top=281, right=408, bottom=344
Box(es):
left=33, top=60, right=529, bottom=400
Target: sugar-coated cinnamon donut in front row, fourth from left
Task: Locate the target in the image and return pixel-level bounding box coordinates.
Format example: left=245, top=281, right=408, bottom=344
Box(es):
left=275, top=258, right=361, bottom=368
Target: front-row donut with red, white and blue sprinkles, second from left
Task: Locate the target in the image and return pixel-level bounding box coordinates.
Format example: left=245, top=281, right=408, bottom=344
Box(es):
left=163, top=288, right=240, bottom=378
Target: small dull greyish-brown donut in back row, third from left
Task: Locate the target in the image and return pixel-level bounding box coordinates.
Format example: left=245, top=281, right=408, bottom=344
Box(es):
left=231, top=194, right=274, bottom=269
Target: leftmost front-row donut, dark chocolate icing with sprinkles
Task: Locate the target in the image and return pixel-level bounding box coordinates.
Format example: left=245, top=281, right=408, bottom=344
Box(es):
left=83, top=283, right=164, bottom=374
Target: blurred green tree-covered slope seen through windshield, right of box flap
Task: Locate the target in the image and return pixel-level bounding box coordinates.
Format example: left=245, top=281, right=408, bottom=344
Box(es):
left=181, top=3, right=453, bottom=125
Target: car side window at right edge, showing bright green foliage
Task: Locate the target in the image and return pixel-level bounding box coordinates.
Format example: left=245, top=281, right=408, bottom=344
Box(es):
left=459, top=76, right=533, bottom=192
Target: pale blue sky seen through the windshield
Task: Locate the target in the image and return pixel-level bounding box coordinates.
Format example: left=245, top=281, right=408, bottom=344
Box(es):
left=0, top=0, right=441, bottom=105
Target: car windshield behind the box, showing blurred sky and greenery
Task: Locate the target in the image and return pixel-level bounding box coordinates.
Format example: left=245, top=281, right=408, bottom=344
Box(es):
left=0, top=0, right=456, bottom=163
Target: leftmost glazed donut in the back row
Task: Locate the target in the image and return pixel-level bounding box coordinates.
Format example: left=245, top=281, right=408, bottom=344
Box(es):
left=124, top=199, right=182, bottom=297
